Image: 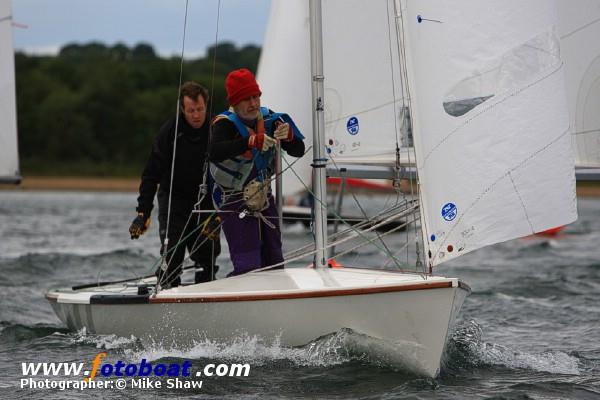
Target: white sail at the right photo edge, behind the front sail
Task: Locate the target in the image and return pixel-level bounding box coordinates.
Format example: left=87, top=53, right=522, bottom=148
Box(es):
left=558, top=0, right=600, bottom=168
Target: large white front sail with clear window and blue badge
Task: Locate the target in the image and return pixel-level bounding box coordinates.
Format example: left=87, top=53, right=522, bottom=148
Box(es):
left=403, top=0, right=577, bottom=265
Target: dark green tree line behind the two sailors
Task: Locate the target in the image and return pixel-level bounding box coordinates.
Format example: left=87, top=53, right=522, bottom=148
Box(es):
left=15, top=42, right=260, bottom=176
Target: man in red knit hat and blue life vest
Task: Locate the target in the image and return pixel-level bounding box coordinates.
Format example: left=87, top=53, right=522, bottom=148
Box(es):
left=209, top=68, right=304, bottom=275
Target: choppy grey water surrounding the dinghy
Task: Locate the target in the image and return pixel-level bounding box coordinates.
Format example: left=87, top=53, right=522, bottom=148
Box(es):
left=0, top=192, right=600, bottom=399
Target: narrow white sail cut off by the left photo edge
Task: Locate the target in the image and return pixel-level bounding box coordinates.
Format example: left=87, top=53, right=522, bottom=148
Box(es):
left=0, top=0, right=21, bottom=183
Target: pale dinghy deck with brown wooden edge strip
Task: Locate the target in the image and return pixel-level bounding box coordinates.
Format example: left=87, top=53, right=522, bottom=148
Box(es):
left=46, top=268, right=466, bottom=304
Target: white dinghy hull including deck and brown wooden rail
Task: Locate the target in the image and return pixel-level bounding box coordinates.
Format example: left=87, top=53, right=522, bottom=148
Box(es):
left=46, top=269, right=469, bottom=377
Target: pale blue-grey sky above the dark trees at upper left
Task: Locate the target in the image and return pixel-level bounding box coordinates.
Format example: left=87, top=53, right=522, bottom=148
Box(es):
left=11, top=0, right=270, bottom=57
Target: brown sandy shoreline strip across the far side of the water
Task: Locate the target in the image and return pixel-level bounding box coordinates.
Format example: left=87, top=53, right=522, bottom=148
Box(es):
left=0, top=176, right=600, bottom=198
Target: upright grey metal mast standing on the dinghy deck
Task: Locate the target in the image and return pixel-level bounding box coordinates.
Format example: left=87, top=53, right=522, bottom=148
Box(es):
left=309, top=0, right=327, bottom=268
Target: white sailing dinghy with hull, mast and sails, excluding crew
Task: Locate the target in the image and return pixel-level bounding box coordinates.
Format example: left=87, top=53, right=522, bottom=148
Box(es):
left=46, top=0, right=577, bottom=377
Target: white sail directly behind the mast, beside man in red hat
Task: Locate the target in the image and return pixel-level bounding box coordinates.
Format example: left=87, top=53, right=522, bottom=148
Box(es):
left=257, top=0, right=414, bottom=195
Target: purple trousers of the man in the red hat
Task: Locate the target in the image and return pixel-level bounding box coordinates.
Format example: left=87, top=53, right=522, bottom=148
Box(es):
left=220, top=194, right=283, bottom=276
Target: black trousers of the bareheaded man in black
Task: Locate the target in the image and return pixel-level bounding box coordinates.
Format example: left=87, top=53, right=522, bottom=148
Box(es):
left=157, top=193, right=221, bottom=286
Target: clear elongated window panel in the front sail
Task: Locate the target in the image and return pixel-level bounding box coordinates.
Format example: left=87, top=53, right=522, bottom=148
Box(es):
left=443, top=31, right=561, bottom=117
